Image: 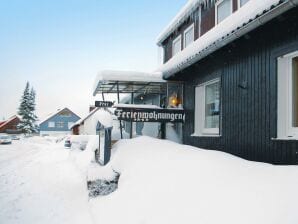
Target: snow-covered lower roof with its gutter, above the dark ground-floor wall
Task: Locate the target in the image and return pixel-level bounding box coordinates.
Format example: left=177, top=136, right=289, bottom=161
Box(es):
left=157, top=0, right=298, bottom=78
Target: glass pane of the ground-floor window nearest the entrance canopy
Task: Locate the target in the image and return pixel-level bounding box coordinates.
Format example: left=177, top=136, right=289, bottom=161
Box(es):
left=205, top=82, right=220, bottom=128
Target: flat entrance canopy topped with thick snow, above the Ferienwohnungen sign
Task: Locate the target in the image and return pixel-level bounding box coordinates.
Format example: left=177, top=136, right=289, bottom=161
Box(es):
left=93, top=70, right=167, bottom=96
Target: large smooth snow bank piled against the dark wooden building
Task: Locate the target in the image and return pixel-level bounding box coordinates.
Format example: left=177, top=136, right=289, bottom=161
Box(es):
left=90, top=137, right=298, bottom=224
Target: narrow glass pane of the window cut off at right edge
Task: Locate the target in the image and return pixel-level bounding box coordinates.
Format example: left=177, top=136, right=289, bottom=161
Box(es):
left=292, top=57, right=298, bottom=127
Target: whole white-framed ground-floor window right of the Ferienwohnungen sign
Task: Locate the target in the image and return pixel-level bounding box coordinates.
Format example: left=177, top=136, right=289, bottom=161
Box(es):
left=195, top=79, right=220, bottom=136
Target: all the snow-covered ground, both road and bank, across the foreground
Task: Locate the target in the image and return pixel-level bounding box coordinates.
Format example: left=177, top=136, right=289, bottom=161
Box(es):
left=0, top=136, right=298, bottom=224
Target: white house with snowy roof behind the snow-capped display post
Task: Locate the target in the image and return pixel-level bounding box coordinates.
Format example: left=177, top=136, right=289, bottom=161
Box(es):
left=71, top=108, right=120, bottom=138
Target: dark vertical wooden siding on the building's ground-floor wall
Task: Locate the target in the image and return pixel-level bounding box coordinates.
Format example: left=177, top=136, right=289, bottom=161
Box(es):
left=175, top=7, right=298, bottom=164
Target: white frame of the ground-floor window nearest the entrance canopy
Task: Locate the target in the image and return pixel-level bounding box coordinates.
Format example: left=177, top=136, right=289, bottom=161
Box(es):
left=192, top=78, right=221, bottom=137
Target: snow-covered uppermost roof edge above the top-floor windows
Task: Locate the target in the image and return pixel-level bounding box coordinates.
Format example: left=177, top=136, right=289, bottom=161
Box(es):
left=157, top=0, right=215, bottom=46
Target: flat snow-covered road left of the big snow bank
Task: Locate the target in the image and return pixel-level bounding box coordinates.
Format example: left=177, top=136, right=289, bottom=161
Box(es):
left=0, top=138, right=93, bottom=224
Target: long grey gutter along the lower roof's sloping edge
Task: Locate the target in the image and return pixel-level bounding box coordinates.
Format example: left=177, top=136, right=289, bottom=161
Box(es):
left=163, top=0, right=298, bottom=79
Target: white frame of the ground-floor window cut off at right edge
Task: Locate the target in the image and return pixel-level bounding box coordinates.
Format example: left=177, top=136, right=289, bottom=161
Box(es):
left=277, top=51, right=298, bottom=140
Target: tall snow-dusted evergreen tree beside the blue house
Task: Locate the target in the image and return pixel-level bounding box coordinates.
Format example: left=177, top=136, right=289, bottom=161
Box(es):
left=18, top=82, right=37, bottom=134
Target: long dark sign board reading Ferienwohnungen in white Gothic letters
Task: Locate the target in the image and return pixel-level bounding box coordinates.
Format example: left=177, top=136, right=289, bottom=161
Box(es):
left=115, top=107, right=185, bottom=123
